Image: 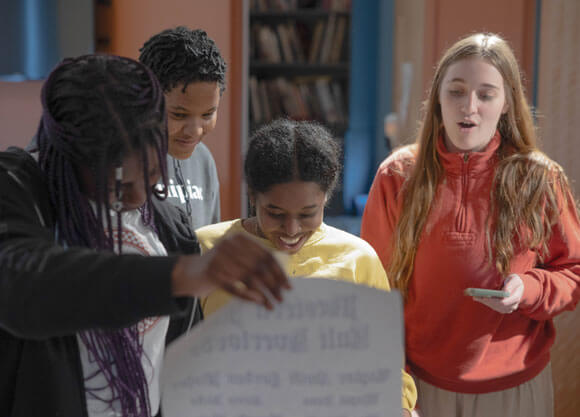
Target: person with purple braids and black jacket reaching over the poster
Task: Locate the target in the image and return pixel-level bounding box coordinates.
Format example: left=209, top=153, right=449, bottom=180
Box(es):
left=0, top=55, right=289, bottom=417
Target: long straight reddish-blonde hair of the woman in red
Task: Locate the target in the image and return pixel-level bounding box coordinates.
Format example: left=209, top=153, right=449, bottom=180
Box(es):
left=387, top=33, right=569, bottom=296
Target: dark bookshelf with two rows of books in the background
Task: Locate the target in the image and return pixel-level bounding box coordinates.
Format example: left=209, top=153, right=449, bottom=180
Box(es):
left=248, top=0, right=350, bottom=137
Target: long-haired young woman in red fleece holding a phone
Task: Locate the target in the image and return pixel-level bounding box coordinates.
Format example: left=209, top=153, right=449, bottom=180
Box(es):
left=361, top=34, right=580, bottom=417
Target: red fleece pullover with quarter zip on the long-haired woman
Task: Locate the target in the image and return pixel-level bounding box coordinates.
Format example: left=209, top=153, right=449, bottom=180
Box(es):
left=361, top=134, right=580, bottom=393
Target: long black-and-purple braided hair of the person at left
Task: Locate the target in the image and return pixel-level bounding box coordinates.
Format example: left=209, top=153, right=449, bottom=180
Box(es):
left=37, top=55, right=167, bottom=417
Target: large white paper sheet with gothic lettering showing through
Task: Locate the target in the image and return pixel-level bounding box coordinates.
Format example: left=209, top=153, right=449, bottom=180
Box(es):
left=162, top=278, right=403, bottom=417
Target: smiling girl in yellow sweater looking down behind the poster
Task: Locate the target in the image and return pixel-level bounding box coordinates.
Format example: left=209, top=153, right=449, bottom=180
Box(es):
left=196, top=119, right=416, bottom=415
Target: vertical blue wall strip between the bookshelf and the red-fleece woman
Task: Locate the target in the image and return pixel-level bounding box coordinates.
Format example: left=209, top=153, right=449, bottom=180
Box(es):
left=343, top=0, right=394, bottom=214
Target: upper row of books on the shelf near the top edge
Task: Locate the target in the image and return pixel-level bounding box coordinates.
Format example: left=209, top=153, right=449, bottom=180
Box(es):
left=250, top=14, right=348, bottom=64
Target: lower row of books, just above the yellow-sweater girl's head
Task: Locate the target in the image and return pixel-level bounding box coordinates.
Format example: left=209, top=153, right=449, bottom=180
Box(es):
left=249, top=76, right=348, bottom=125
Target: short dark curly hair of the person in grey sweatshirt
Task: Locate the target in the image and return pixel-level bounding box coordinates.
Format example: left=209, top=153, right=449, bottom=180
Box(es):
left=139, top=26, right=226, bottom=93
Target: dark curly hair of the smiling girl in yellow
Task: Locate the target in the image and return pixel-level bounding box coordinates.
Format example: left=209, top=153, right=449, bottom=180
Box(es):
left=244, top=119, right=342, bottom=197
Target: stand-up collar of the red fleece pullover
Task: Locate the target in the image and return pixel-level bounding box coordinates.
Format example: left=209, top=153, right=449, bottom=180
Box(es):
left=437, top=130, right=501, bottom=175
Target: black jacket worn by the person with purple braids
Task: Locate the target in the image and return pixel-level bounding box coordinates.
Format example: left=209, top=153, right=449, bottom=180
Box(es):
left=0, top=148, right=201, bottom=417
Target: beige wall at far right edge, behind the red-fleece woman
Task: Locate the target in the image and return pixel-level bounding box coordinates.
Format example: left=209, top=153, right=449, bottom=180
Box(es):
left=538, top=0, right=580, bottom=417
